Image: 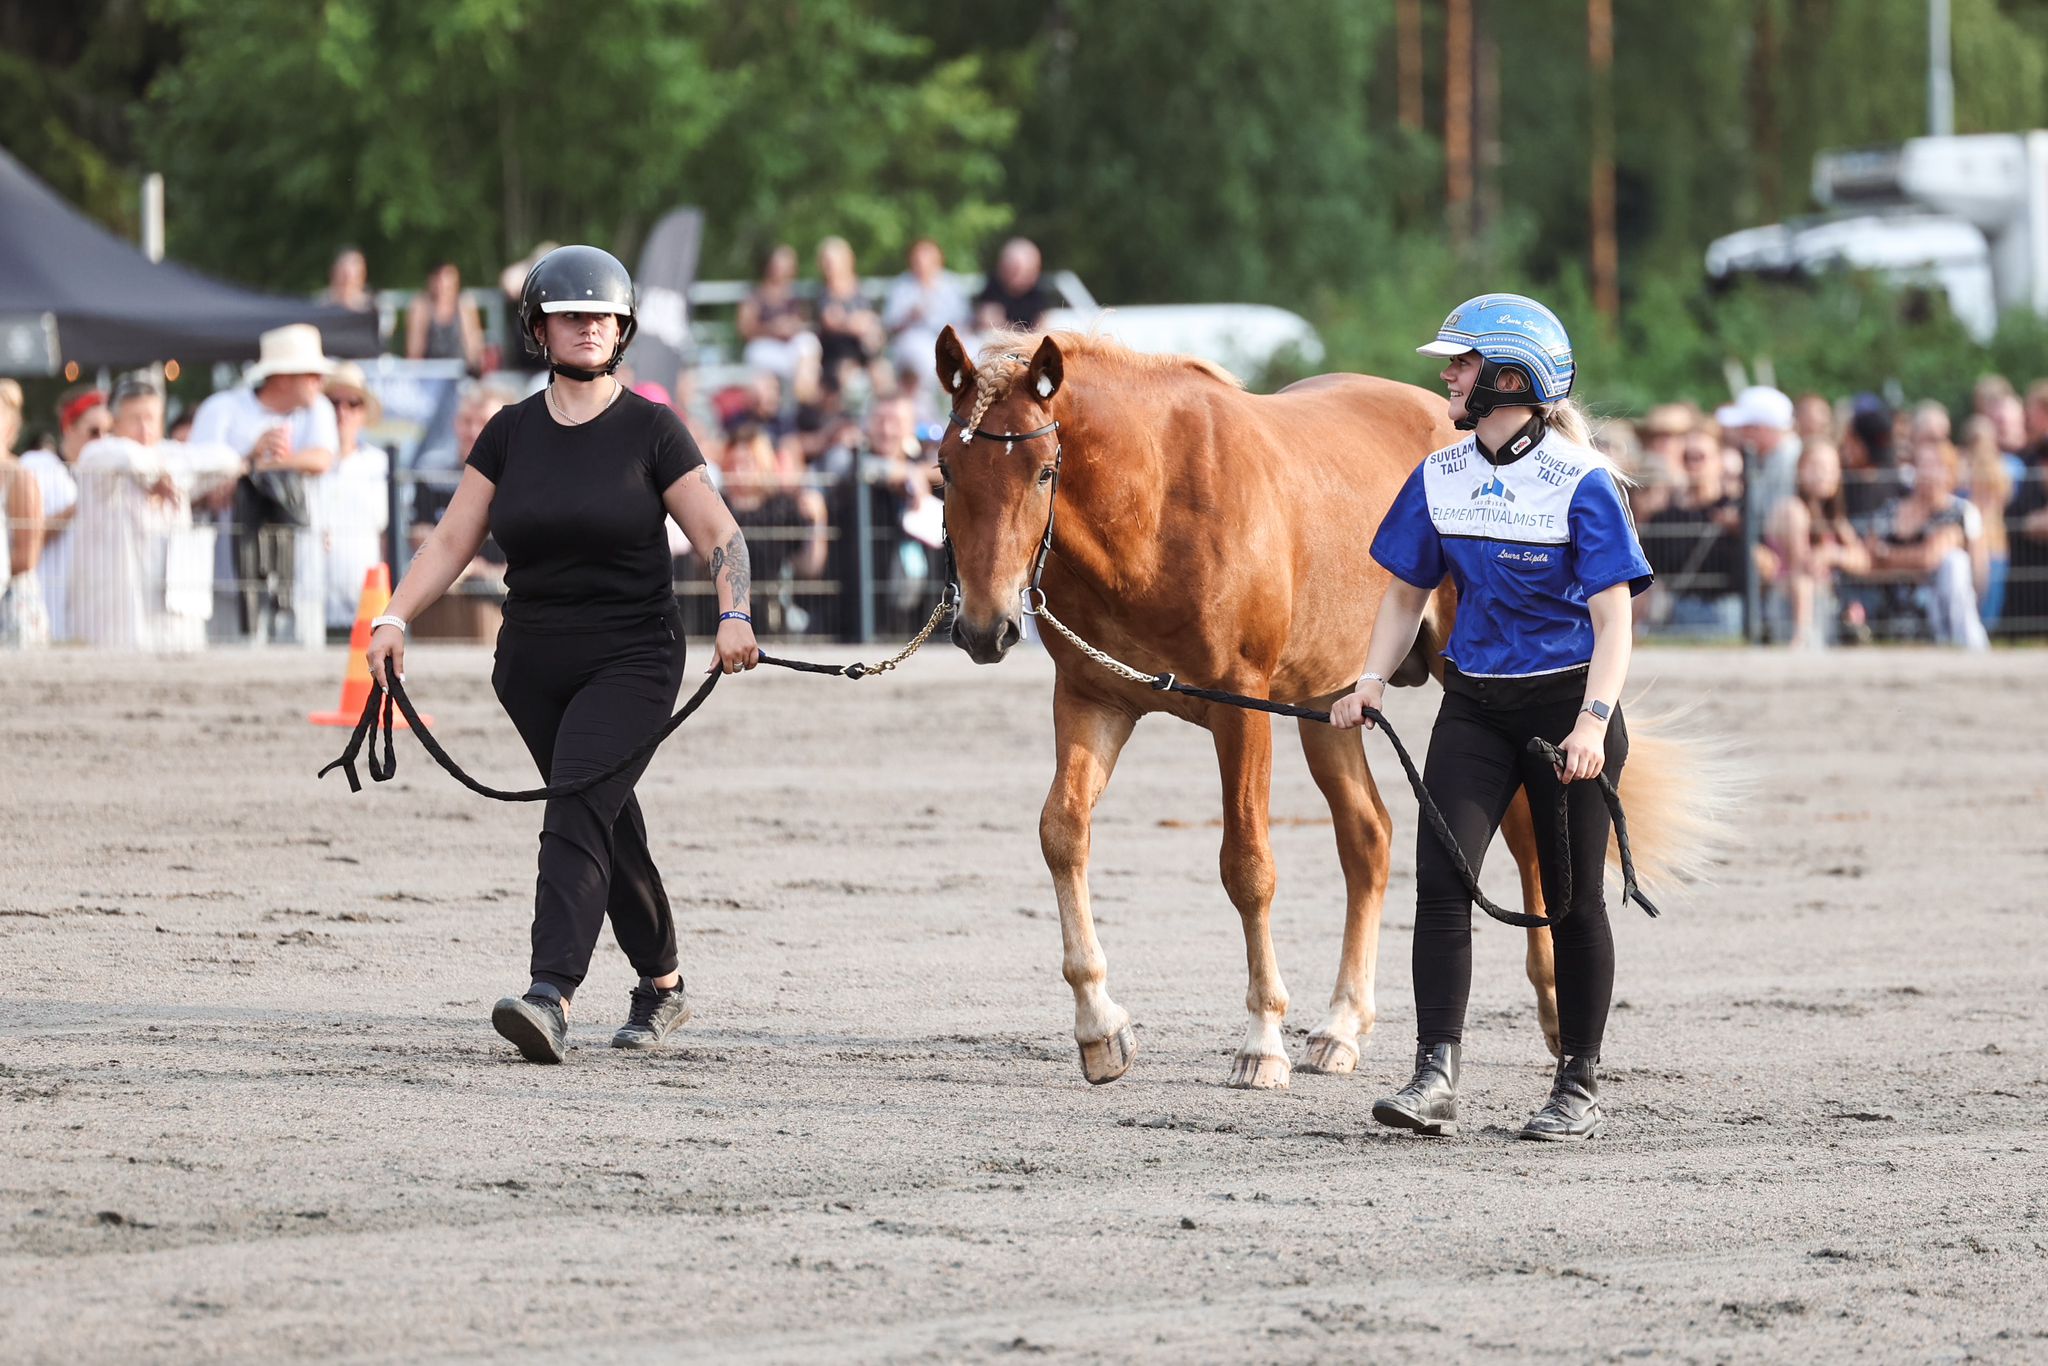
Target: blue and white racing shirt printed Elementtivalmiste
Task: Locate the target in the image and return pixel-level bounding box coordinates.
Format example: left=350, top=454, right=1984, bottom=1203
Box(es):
left=1372, top=432, right=1651, bottom=678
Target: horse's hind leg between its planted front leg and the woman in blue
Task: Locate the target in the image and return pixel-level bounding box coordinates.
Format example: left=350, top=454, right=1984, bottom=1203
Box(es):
left=1300, top=721, right=1395, bottom=1071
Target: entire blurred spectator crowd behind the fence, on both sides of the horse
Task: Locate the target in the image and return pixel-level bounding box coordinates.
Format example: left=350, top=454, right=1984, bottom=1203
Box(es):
left=0, top=225, right=2048, bottom=651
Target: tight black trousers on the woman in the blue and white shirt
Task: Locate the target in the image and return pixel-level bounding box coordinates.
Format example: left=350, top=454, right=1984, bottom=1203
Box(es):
left=1413, top=670, right=1628, bottom=1057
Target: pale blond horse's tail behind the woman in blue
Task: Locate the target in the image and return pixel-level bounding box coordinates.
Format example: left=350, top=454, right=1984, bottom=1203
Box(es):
left=1608, top=709, right=1745, bottom=887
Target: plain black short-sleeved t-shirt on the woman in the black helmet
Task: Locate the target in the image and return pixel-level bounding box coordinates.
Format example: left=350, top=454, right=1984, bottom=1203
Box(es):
left=469, top=391, right=705, bottom=631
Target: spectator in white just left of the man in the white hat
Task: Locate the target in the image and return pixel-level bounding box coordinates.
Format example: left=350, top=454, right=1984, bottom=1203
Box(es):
left=68, top=381, right=242, bottom=651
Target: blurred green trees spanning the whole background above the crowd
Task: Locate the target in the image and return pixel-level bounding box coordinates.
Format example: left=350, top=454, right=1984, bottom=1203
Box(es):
left=0, top=0, right=2048, bottom=410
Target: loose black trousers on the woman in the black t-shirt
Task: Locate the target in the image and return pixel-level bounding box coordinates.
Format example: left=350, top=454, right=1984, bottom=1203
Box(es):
left=492, top=608, right=684, bottom=997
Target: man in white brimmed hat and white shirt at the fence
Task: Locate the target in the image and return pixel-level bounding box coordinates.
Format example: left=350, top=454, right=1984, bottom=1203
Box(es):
left=190, top=324, right=340, bottom=645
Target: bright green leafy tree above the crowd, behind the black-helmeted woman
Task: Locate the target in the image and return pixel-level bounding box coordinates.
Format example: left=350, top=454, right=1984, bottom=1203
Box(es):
left=143, top=0, right=1014, bottom=287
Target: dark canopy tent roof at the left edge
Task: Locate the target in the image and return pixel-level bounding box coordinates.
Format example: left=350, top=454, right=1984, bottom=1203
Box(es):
left=0, top=150, right=381, bottom=375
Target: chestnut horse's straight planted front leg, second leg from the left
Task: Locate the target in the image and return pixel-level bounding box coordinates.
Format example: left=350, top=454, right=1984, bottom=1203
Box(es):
left=1208, top=707, right=1290, bottom=1087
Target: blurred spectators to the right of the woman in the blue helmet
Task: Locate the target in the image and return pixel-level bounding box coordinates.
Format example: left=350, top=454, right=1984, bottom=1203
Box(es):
left=1595, top=375, right=2048, bottom=649
